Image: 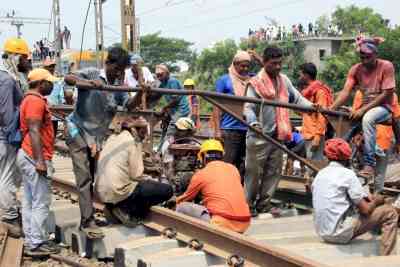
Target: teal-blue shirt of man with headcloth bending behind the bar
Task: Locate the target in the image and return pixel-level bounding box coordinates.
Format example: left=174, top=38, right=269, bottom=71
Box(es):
left=160, top=77, right=190, bottom=118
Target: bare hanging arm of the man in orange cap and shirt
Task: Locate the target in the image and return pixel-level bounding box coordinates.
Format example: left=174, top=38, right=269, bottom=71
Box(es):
left=27, top=119, right=47, bottom=175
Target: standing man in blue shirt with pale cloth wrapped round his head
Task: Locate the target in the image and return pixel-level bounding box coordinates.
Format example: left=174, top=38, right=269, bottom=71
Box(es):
left=213, top=50, right=251, bottom=176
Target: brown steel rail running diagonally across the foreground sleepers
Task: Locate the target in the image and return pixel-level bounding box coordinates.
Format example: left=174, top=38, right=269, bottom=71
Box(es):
left=53, top=178, right=327, bottom=267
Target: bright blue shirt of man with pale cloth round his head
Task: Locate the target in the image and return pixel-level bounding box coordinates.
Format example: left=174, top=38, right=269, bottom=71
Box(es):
left=215, top=74, right=247, bottom=131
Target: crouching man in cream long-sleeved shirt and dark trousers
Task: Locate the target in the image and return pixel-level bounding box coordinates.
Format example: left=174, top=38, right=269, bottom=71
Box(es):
left=95, top=119, right=173, bottom=227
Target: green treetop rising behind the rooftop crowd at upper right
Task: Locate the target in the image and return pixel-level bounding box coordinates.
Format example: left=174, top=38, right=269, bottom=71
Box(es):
left=332, top=5, right=389, bottom=35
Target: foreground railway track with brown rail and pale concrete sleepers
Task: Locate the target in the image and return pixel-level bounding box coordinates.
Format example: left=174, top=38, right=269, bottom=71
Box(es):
left=44, top=156, right=400, bottom=267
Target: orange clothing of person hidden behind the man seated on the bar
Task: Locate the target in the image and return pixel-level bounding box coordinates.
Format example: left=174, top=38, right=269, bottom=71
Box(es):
left=353, top=90, right=394, bottom=150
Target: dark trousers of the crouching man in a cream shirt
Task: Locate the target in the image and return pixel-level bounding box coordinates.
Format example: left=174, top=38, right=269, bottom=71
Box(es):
left=117, top=180, right=173, bottom=218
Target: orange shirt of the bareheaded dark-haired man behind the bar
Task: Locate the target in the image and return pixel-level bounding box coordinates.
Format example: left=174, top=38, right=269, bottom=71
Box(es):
left=301, top=86, right=329, bottom=140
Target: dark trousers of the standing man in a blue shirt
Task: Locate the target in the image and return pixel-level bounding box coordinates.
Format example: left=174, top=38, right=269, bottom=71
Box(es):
left=222, top=130, right=247, bottom=177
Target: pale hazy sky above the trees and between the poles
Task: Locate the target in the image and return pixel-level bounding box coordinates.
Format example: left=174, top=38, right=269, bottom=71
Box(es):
left=0, top=0, right=400, bottom=50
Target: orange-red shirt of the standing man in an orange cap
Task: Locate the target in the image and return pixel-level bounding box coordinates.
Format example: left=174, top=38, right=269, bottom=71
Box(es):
left=20, top=91, right=54, bottom=160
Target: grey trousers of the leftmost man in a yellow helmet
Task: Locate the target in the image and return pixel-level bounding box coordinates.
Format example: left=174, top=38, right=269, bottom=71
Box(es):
left=0, top=141, right=21, bottom=220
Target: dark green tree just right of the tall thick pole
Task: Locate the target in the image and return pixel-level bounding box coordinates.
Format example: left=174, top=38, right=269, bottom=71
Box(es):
left=140, top=32, right=196, bottom=71
